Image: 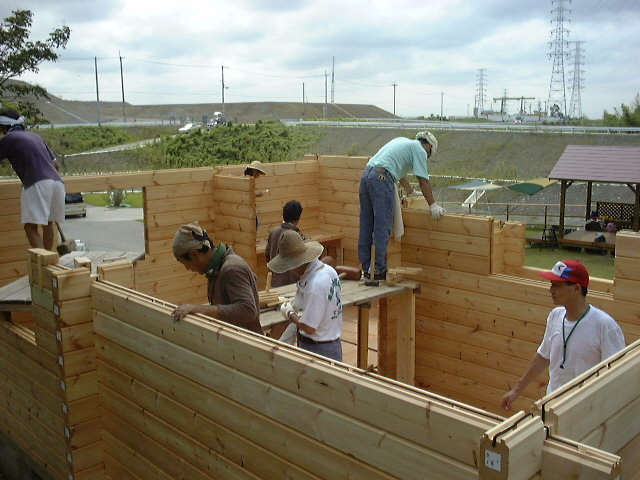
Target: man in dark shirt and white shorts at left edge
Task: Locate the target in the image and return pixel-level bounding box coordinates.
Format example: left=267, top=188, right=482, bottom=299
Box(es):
left=0, top=109, right=64, bottom=250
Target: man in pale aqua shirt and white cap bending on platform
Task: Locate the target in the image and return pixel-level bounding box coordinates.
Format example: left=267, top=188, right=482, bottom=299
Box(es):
left=358, top=131, right=446, bottom=280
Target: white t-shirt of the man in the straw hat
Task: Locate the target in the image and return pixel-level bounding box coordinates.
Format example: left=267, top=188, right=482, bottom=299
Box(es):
left=294, top=259, right=342, bottom=342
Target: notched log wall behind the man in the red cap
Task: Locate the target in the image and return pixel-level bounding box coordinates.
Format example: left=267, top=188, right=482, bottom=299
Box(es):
left=396, top=209, right=640, bottom=412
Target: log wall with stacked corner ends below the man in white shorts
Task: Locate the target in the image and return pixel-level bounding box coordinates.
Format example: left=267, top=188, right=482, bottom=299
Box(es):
left=0, top=249, right=104, bottom=480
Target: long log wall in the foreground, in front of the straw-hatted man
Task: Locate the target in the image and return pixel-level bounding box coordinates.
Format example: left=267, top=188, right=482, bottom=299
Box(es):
left=92, top=282, right=501, bottom=480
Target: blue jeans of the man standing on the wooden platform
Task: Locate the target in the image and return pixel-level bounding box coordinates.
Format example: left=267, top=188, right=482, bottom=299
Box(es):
left=358, top=167, right=396, bottom=273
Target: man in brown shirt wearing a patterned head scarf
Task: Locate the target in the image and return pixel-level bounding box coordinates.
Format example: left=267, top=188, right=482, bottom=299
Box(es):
left=173, top=222, right=262, bottom=334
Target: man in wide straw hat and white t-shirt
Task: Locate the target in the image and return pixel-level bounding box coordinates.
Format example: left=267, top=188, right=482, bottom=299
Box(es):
left=267, top=230, right=342, bottom=362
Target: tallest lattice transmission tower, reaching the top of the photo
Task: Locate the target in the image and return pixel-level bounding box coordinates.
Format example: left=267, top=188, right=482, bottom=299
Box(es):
left=547, top=0, right=571, bottom=116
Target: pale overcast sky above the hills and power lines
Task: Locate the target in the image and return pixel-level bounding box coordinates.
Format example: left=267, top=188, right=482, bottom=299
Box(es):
left=0, top=0, right=640, bottom=118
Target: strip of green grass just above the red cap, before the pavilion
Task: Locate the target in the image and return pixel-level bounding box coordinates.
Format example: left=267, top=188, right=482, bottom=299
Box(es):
left=524, top=246, right=615, bottom=280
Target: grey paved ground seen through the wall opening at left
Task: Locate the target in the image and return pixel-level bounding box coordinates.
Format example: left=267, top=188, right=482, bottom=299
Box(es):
left=61, top=205, right=144, bottom=252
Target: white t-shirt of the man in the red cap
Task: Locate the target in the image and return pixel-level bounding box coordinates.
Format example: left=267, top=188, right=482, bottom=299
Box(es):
left=538, top=305, right=625, bottom=394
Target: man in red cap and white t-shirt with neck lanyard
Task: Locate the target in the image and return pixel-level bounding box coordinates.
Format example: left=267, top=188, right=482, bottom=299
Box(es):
left=500, top=260, right=625, bottom=410
